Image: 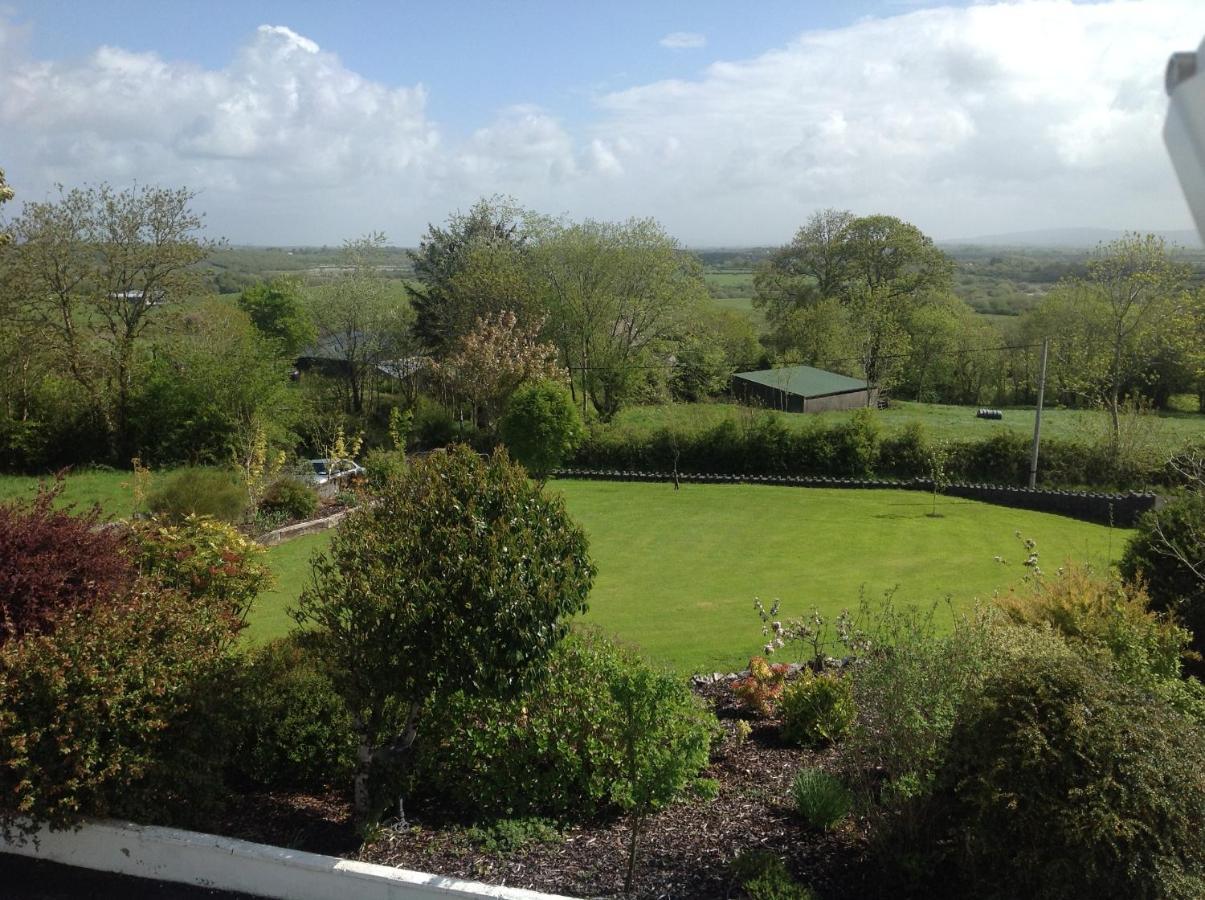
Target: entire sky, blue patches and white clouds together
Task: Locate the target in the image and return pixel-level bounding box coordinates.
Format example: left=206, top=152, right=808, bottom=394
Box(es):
left=0, top=0, right=1205, bottom=247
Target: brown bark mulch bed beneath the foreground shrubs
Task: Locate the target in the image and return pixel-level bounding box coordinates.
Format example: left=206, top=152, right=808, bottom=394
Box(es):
left=216, top=682, right=868, bottom=899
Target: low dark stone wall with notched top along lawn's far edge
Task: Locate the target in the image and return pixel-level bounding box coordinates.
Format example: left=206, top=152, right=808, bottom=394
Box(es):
left=553, top=469, right=1163, bottom=528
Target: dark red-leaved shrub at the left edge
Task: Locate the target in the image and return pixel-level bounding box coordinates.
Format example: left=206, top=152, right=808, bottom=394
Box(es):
left=0, top=486, right=134, bottom=646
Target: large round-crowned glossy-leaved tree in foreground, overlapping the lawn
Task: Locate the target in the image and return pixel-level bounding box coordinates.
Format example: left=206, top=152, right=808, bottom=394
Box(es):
left=292, top=447, right=594, bottom=823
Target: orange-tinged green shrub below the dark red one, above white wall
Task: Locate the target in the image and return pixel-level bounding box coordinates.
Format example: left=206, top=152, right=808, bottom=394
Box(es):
left=0, top=589, right=237, bottom=828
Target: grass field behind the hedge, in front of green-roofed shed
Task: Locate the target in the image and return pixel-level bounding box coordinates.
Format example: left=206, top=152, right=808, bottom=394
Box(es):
left=612, top=401, right=1205, bottom=446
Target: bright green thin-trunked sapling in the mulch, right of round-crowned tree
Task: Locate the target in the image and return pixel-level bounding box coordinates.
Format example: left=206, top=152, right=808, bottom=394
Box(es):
left=611, top=666, right=711, bottom=893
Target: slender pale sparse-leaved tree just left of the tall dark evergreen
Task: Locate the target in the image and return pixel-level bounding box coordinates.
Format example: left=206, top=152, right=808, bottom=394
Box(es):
left=303, top=234, right=413, bottom=413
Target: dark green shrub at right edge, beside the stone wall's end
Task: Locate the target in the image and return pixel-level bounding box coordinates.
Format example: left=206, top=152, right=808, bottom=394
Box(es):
left=1121, top=493, right=1205, bottom=673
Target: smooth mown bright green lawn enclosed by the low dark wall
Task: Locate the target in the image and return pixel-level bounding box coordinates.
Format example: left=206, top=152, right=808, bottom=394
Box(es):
left=249, top=481, right=1128, bottom=671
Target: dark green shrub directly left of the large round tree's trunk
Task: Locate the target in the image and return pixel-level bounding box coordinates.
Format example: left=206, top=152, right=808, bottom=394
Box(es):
left=234, top=636, right=355, bottom=789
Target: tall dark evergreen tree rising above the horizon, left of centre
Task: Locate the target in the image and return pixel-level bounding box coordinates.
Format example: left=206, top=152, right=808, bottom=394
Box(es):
left=406, top=196, right=535, bottom=357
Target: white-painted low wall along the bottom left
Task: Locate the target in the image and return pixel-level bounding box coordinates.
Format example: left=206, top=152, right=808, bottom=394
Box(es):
left=0, top=820, right=565, bottom=900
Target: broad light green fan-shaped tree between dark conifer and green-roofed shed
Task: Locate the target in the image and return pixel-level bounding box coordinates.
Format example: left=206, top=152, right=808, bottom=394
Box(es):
left=531, top=219, right=711, bottom=418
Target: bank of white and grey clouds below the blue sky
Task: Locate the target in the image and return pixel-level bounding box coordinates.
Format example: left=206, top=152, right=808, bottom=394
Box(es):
left=0, top=0, right=1205, bottom=243
